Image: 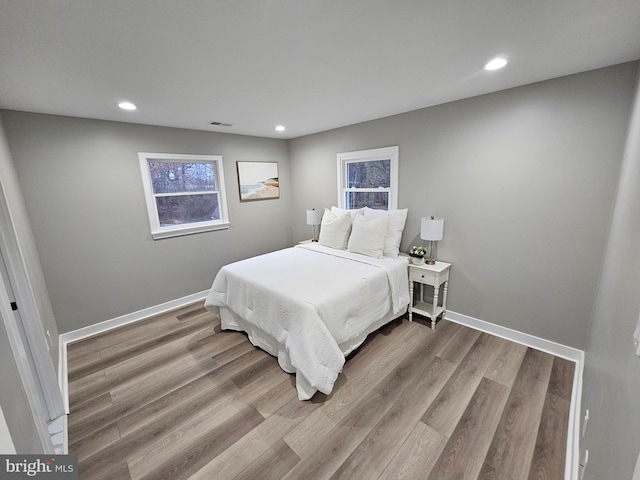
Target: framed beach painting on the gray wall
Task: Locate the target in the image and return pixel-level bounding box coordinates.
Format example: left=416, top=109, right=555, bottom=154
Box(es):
left=236, top=162, right=280, bottom=202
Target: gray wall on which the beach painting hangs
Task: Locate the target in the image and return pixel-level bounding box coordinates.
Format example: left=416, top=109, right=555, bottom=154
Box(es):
left=2, top=111, right=292, bottom=333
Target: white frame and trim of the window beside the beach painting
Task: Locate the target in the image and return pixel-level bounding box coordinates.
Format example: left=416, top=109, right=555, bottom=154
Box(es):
left=138, top=152, right=229, bottom=240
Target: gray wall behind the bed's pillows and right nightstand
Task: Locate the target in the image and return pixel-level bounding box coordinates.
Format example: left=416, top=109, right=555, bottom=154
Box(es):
left=290, top=64, right=636, bottom=349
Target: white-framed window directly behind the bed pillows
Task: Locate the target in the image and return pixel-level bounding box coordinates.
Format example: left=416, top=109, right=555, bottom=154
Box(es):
left=338, top=146, right=398, bottom=210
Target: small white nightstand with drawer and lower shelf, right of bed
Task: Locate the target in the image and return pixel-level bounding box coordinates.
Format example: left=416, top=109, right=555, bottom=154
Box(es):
left=409, top=262, right=451, bottom=328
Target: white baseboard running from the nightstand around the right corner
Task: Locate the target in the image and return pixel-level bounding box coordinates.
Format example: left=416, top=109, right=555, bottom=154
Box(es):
left=445, top=310, right=584, bottom=480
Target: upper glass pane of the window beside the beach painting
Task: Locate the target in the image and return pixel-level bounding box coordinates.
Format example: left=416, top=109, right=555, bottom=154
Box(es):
left=149, top=161, right=216, bottom=193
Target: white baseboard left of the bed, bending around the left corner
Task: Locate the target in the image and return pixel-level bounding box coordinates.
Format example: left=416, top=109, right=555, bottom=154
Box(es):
left=58, top=290, right=209, bottom=415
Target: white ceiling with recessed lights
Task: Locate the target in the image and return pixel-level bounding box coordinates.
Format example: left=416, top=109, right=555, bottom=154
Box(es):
left=0, top=0, right=640, bottom=138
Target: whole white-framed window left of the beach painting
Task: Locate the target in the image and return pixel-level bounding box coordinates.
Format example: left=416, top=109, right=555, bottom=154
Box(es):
left=138, top=152, right=229, bottom=239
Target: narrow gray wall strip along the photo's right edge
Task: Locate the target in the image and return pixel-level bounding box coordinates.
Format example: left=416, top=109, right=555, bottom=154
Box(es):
left=582, top=66, right=640, bottom=480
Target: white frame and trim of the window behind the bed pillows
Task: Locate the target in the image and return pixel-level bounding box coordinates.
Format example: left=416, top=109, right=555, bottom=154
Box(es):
left=338, top=145, right=399, bottom=210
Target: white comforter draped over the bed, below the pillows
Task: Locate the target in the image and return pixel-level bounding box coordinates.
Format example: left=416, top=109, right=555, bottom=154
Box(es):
left=205, top=244, right=409, bottom=400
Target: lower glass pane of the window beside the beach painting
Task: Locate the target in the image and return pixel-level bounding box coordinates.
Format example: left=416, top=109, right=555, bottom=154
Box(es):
left=156, top=194, right=220, bottom=227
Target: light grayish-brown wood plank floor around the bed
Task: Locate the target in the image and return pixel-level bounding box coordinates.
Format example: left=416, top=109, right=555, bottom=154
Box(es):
left=68, top=305, right=574, bottom=480
